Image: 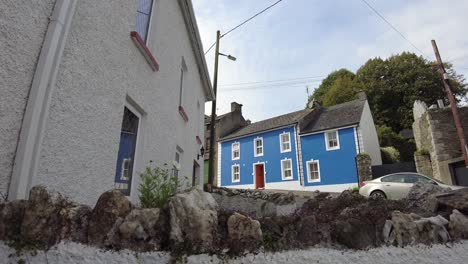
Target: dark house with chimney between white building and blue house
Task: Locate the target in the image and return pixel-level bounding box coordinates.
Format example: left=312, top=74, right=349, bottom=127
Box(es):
left=204, top=102, right=250, bottom=186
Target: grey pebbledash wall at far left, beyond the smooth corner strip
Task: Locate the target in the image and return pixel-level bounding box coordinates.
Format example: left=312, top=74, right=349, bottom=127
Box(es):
left=0, top=0, right=55, bottom=198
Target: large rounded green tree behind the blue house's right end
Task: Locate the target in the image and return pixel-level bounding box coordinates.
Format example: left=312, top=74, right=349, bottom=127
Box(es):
left=356, top=52, right=467, bottom=132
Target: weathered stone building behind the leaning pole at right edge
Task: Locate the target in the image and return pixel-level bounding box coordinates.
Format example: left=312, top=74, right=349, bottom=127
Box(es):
left=413, top=101, right=468, bottom=186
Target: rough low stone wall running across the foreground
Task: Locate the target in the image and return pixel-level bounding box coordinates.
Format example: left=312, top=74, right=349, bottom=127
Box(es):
left=0, top=184, right=468, bottom=255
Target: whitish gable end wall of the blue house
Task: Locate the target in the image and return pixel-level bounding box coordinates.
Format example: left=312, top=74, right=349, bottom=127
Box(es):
left=359, top=101, right=382, bottom=166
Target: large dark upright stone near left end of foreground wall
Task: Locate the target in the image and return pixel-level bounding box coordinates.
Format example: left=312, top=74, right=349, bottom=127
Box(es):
left=21, top=186, right=67, bottom=247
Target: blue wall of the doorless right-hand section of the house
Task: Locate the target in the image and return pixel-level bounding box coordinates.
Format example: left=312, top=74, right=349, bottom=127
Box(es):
left=301, top=128, right=358, bottom=186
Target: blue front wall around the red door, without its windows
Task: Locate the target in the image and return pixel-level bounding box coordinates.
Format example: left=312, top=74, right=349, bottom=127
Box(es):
left=220, top=127, right=299, bottom=186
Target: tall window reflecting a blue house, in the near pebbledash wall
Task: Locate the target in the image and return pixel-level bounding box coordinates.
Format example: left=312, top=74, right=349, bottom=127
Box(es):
left=115, top=107, right=139, bottom=195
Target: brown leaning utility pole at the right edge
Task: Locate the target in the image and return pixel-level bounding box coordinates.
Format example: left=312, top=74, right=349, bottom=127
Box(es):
left=431, top=40, right=468, bottom=168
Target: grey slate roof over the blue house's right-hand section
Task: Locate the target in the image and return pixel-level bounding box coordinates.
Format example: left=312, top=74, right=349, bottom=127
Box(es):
left=301, top=100, right=366, bottom=134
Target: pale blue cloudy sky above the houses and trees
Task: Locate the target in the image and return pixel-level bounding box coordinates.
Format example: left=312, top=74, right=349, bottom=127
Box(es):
left=192, top=0, right=468, bottom=122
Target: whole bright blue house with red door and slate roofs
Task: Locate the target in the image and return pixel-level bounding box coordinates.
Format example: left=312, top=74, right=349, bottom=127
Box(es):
left=217, top=99, right=382, bottom=191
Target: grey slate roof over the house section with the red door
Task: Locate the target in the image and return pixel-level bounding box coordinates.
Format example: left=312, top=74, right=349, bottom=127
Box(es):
left=220, top=110, right=310, bottom=140
